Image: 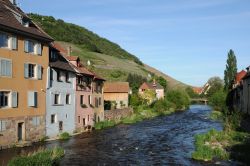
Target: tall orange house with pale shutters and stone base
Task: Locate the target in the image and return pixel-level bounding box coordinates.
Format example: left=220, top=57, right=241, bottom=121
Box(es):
left=0, top=0, right=53, bottom=148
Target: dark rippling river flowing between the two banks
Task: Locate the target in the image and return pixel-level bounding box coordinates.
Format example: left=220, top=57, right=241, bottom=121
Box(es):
left=0, top=105, right=232, bottom=165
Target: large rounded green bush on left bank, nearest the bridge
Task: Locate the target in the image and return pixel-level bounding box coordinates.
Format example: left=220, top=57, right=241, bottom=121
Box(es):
left=167, top=90, right=190, bottom=110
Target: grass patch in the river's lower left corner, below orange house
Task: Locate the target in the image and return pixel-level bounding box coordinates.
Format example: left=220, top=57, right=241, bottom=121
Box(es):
left=8, top=147, right=64, bottom=166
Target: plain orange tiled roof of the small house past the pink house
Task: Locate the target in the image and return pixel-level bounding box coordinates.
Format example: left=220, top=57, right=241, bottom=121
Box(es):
left=104, top=82, right=130, bottom=93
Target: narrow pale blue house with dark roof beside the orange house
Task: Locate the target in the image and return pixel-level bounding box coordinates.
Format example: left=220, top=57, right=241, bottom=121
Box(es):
left=46, top=46, right=76, bottom=137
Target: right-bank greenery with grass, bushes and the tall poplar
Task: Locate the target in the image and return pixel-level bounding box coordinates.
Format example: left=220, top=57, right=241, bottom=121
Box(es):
left=192, top=50, right=250, bottom=164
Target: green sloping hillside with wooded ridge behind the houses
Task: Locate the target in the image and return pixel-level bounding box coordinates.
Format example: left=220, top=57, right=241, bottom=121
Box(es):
left=29, top=14, right=187, bottom=88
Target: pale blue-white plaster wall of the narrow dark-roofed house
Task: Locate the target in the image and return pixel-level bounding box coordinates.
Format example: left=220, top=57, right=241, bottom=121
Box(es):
left=46, top=69, right=76, bottom=137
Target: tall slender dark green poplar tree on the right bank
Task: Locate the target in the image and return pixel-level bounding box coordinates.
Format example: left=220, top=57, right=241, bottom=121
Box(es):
left=224, top=50, right=237, bottom=91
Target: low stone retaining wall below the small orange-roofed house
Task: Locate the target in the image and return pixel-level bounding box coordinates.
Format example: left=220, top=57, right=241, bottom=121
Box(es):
left=104, top=108, right=134, bottom=120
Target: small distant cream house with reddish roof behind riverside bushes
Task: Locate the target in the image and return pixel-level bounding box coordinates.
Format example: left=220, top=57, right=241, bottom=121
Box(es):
left=139, top=80, right=164, bottom=100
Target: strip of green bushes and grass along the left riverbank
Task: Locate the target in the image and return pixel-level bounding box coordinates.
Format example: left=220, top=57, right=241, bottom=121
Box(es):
left=95, top=90, right=190, bottom=129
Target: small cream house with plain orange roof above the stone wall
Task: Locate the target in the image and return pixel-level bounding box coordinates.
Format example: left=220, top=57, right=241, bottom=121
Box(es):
left=104, top=82, right=130, bottom=109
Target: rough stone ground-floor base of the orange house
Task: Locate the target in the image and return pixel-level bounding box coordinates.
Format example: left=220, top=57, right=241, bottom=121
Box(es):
left=0, top=116, right=45, bottom=149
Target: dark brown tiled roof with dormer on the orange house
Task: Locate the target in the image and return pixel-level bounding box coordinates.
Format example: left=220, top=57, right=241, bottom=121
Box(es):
left=0, top=0, right=53, bottom=42
